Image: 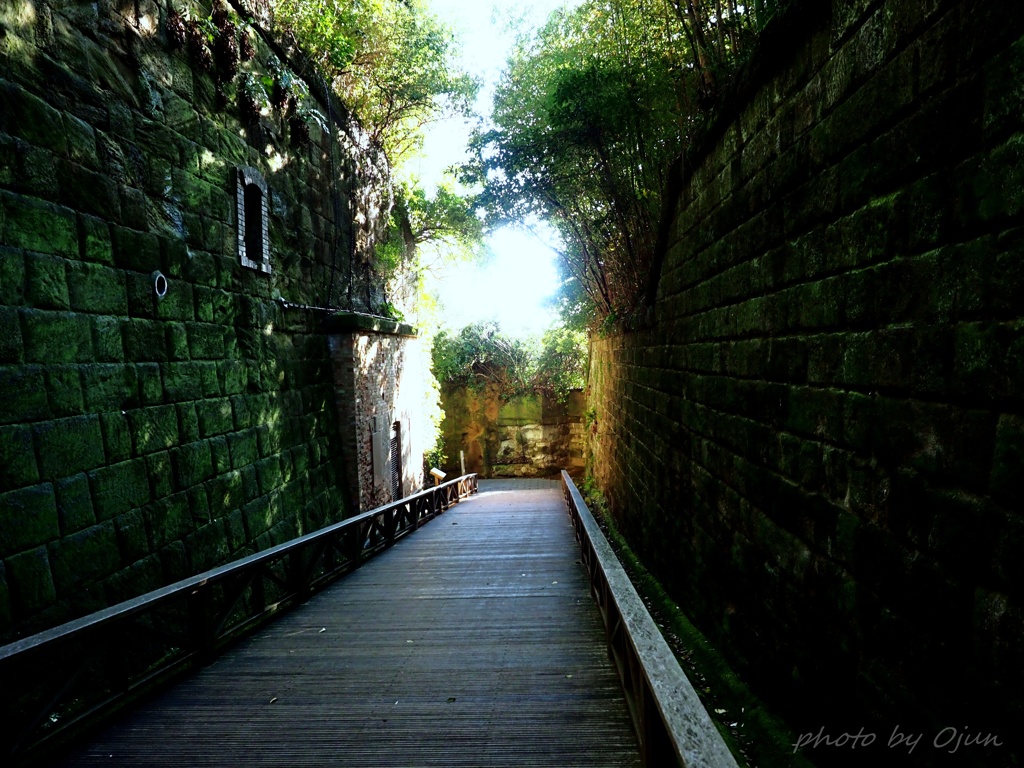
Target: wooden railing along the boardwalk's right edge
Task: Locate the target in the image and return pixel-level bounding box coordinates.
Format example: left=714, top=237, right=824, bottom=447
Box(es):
left=562, top=470, right=736, bottom=768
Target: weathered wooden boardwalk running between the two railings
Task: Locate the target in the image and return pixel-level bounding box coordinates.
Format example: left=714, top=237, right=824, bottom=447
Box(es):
left=60, top=480, right=640, bottom=768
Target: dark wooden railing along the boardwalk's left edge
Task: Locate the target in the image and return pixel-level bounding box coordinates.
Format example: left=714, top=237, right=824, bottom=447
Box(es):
left=0, top=474, right=477, bottom=762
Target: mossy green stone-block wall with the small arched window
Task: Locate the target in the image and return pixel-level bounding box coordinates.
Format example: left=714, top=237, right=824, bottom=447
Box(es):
left=0, top=0, right=389, bottom=641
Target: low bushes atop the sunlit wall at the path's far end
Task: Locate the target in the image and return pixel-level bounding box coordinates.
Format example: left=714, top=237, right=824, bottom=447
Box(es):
left=432, top=323, right=587, bottom=401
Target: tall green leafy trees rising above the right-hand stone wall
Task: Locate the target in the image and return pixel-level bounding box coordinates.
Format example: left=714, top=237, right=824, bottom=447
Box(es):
left=462, top=0, right=782, bottom=325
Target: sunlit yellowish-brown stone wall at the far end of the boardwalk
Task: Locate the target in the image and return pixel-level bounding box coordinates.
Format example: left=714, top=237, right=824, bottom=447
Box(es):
left=441, top=388, right=584, bottom=477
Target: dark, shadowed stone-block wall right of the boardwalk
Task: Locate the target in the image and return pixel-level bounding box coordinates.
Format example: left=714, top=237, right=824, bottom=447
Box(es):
left=589, top=0, right=1024, bottom=765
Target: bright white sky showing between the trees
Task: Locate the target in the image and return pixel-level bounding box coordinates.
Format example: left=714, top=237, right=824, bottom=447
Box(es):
left=414, top=0, right=566, bottom=336
